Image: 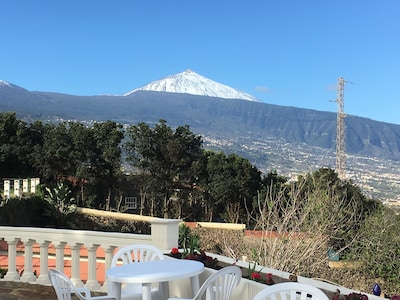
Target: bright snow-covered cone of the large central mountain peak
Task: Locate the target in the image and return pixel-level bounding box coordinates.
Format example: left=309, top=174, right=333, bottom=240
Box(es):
left=124, top=70, right=260, bottom=102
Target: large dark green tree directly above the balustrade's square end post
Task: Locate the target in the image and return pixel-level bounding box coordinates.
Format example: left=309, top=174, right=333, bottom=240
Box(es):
left=125, top=120, right=202, bottom=218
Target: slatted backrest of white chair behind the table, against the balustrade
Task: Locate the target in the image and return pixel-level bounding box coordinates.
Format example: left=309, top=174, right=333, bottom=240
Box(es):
left=111, top=244, right=165, bottom=267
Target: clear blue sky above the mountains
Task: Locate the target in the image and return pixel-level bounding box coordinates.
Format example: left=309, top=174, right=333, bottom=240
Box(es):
left=0, top=0, right=400, bottom=124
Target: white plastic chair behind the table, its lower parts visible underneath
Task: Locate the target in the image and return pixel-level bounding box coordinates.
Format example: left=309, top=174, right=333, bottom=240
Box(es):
left=111, top=244, right=168, bottom=300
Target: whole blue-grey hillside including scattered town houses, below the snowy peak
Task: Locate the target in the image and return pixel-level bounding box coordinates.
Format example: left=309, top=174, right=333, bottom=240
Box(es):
left=0, top=85, right=400, bottom=200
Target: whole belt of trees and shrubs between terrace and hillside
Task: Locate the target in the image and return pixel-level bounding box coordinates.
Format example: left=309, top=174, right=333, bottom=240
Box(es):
left=0, top=113, right=400, bottom=294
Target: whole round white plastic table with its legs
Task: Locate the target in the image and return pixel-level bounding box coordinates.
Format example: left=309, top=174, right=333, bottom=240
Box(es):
left=106, top=259, right=204, bottom=300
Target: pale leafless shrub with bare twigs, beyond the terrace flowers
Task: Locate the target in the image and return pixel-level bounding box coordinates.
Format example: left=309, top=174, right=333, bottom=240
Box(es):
left=247, top=179, right=359, bottom=276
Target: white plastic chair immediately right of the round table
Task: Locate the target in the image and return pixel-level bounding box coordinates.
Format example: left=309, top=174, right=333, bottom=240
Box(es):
left=168, top=266, right=242, bottom=300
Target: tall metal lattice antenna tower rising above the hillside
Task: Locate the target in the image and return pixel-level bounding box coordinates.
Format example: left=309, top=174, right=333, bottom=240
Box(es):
left=336, top=77, right=346, bottom=180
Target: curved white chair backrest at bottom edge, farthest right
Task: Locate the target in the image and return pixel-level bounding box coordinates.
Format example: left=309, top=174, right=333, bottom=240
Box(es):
left=253, top=282, right=329, bottom=300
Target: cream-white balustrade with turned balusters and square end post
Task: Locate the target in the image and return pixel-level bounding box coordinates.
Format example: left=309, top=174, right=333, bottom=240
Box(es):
left=0, top=214, right=181, bottom=291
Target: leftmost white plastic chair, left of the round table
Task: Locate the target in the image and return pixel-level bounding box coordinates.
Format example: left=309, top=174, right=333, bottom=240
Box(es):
left=49, top=269, right=116, bottom=300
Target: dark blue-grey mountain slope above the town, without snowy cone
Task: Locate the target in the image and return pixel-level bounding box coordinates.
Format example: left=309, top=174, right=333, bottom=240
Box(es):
left=0, top=83, right=400, bottom=160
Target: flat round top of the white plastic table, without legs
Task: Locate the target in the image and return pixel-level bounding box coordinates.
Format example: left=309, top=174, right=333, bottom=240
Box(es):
left=106, top=259, right=204, bottom=283
